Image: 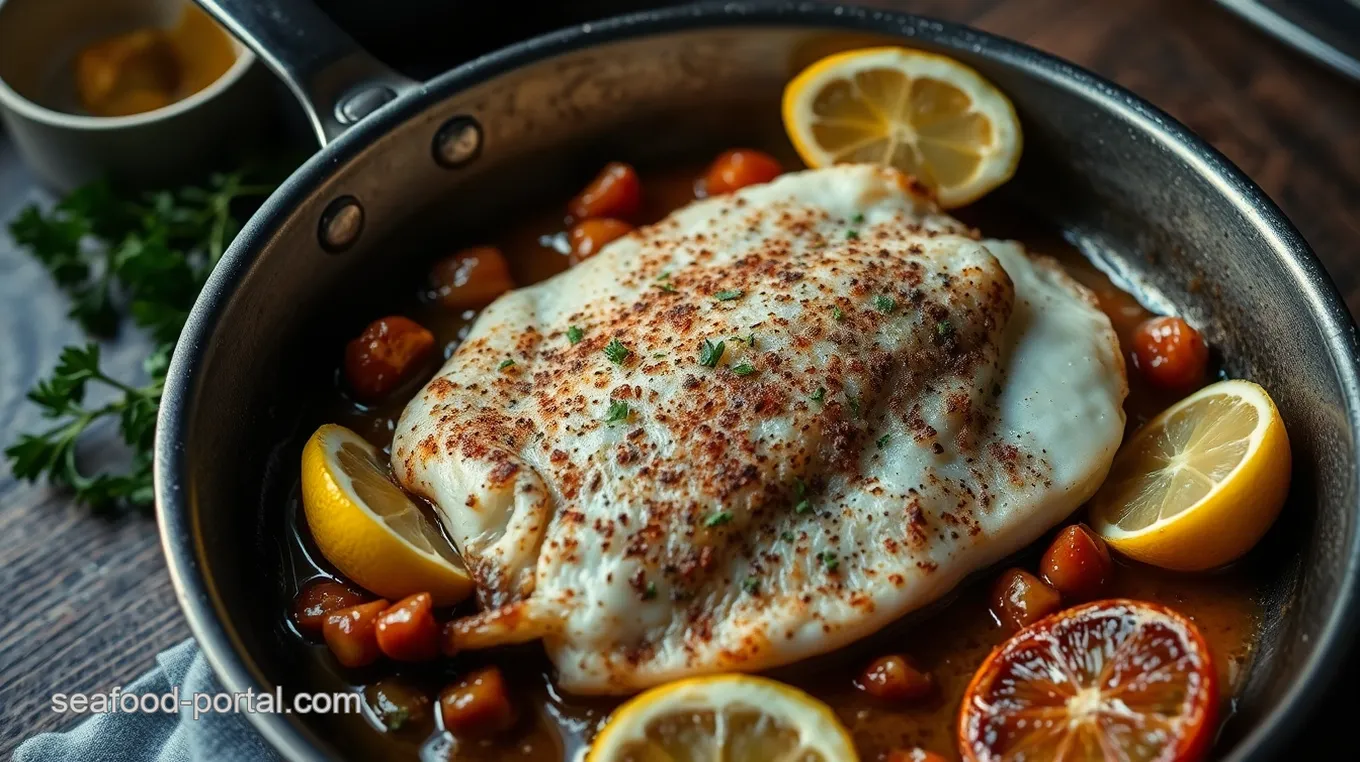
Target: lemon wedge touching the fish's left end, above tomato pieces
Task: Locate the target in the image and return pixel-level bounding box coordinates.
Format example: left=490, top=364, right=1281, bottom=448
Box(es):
left=302, top=423, right=473, bottom=606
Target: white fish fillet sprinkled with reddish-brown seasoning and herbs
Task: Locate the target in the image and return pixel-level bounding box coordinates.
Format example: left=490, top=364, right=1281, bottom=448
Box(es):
left=392, top=166, right=1127, bottom=694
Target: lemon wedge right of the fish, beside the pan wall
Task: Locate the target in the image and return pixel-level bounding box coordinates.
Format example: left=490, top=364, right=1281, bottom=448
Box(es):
left=1091, top=381, right=1291, bottom=572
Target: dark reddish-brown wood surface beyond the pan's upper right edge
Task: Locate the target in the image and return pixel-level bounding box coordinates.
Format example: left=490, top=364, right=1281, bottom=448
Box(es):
left=892, top=0, right=1360, bottom=312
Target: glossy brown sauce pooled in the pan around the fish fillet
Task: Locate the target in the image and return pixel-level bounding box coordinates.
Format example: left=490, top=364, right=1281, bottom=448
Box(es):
left=277, top=156, right=1261, bottom=762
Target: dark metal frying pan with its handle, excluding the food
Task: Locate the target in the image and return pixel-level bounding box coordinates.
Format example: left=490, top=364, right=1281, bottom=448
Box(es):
left=156, top=0, right=1360, bottom=762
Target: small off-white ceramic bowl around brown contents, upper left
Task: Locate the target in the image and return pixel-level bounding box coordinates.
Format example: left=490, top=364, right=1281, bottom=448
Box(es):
left=0, top=0, right=273, bottom=191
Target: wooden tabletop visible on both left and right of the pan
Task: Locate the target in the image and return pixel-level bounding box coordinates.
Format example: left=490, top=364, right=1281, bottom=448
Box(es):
left=0, top=0, right=1360, bottom=759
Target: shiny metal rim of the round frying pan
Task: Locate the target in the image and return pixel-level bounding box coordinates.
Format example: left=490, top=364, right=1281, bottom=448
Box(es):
left=155, top=1, right=1360, bottom=762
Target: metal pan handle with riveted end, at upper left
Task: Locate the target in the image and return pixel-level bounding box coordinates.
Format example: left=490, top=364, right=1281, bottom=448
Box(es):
left=196, top=0, right=420, bottom=146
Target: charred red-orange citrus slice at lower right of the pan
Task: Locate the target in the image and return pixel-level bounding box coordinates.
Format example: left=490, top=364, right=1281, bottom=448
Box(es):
left=959, top=600, right=1219, bottom=762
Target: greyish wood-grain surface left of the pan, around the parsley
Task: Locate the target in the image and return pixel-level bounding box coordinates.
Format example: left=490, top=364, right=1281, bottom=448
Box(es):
left=0, top=137, right=189, bottom=759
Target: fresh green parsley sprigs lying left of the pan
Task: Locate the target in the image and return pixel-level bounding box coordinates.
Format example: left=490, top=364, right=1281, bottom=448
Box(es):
left=4, top=169, right=275, bottom=509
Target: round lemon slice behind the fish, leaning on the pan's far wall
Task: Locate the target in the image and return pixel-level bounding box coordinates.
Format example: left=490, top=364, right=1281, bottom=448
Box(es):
left=783, top=48, right=1021, bottom=208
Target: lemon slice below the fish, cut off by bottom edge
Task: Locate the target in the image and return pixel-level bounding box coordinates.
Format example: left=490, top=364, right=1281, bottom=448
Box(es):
left=586, top=675, right=860, bottom=762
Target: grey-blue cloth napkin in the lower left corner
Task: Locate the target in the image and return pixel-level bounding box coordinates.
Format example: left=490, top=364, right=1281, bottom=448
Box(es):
left=14, top=638, right=280, bottom=762
